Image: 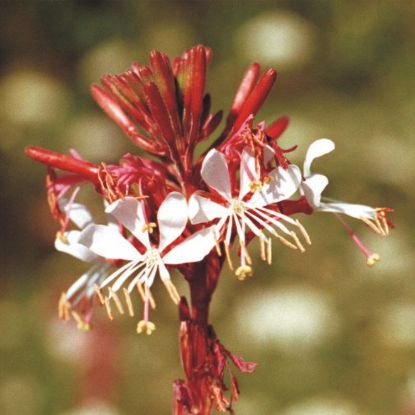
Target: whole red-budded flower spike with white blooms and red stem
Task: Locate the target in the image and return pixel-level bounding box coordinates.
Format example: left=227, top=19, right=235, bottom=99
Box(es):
left=26, top=46, right=391, bottom=413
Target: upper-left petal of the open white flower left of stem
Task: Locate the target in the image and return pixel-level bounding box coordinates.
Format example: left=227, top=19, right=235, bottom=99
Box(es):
left=105, top=197, right=150, bottom=248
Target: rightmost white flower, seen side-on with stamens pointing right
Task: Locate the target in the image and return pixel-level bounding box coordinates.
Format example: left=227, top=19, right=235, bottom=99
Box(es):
left=301, top=138, right=389, bottom=235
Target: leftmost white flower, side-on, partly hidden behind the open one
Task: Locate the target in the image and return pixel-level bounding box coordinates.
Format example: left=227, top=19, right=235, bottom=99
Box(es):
left=55, top=188, right=110, bottom=331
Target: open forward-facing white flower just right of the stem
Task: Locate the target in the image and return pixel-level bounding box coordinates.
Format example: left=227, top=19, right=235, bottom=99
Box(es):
left=189, top=147, right=309, bottom=279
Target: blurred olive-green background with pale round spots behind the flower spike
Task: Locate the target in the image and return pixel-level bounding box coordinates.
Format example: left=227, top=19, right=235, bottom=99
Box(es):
left=0, top=0, right=415, bottom=415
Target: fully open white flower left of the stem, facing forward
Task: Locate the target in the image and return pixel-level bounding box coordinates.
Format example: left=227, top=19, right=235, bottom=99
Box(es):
left=80, top=192, right=215, bottom=334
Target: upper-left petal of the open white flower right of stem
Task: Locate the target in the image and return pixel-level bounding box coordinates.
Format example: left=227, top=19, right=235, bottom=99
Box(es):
left=200, top=149, right=232, bottom=200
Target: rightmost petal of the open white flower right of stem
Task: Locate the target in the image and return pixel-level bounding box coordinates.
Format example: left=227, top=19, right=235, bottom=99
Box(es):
left=247, top=164, right=301, bottom=207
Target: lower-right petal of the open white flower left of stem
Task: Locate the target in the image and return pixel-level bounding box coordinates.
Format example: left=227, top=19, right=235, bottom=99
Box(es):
left=162, top=226, right=215, bottom=264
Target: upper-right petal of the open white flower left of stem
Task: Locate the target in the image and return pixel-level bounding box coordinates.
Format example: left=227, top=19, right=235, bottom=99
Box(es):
left=157, top=192, right=187, bottom=251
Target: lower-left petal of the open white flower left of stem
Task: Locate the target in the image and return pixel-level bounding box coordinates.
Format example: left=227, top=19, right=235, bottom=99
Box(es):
left=79, top=225, right=143, bottom=261
